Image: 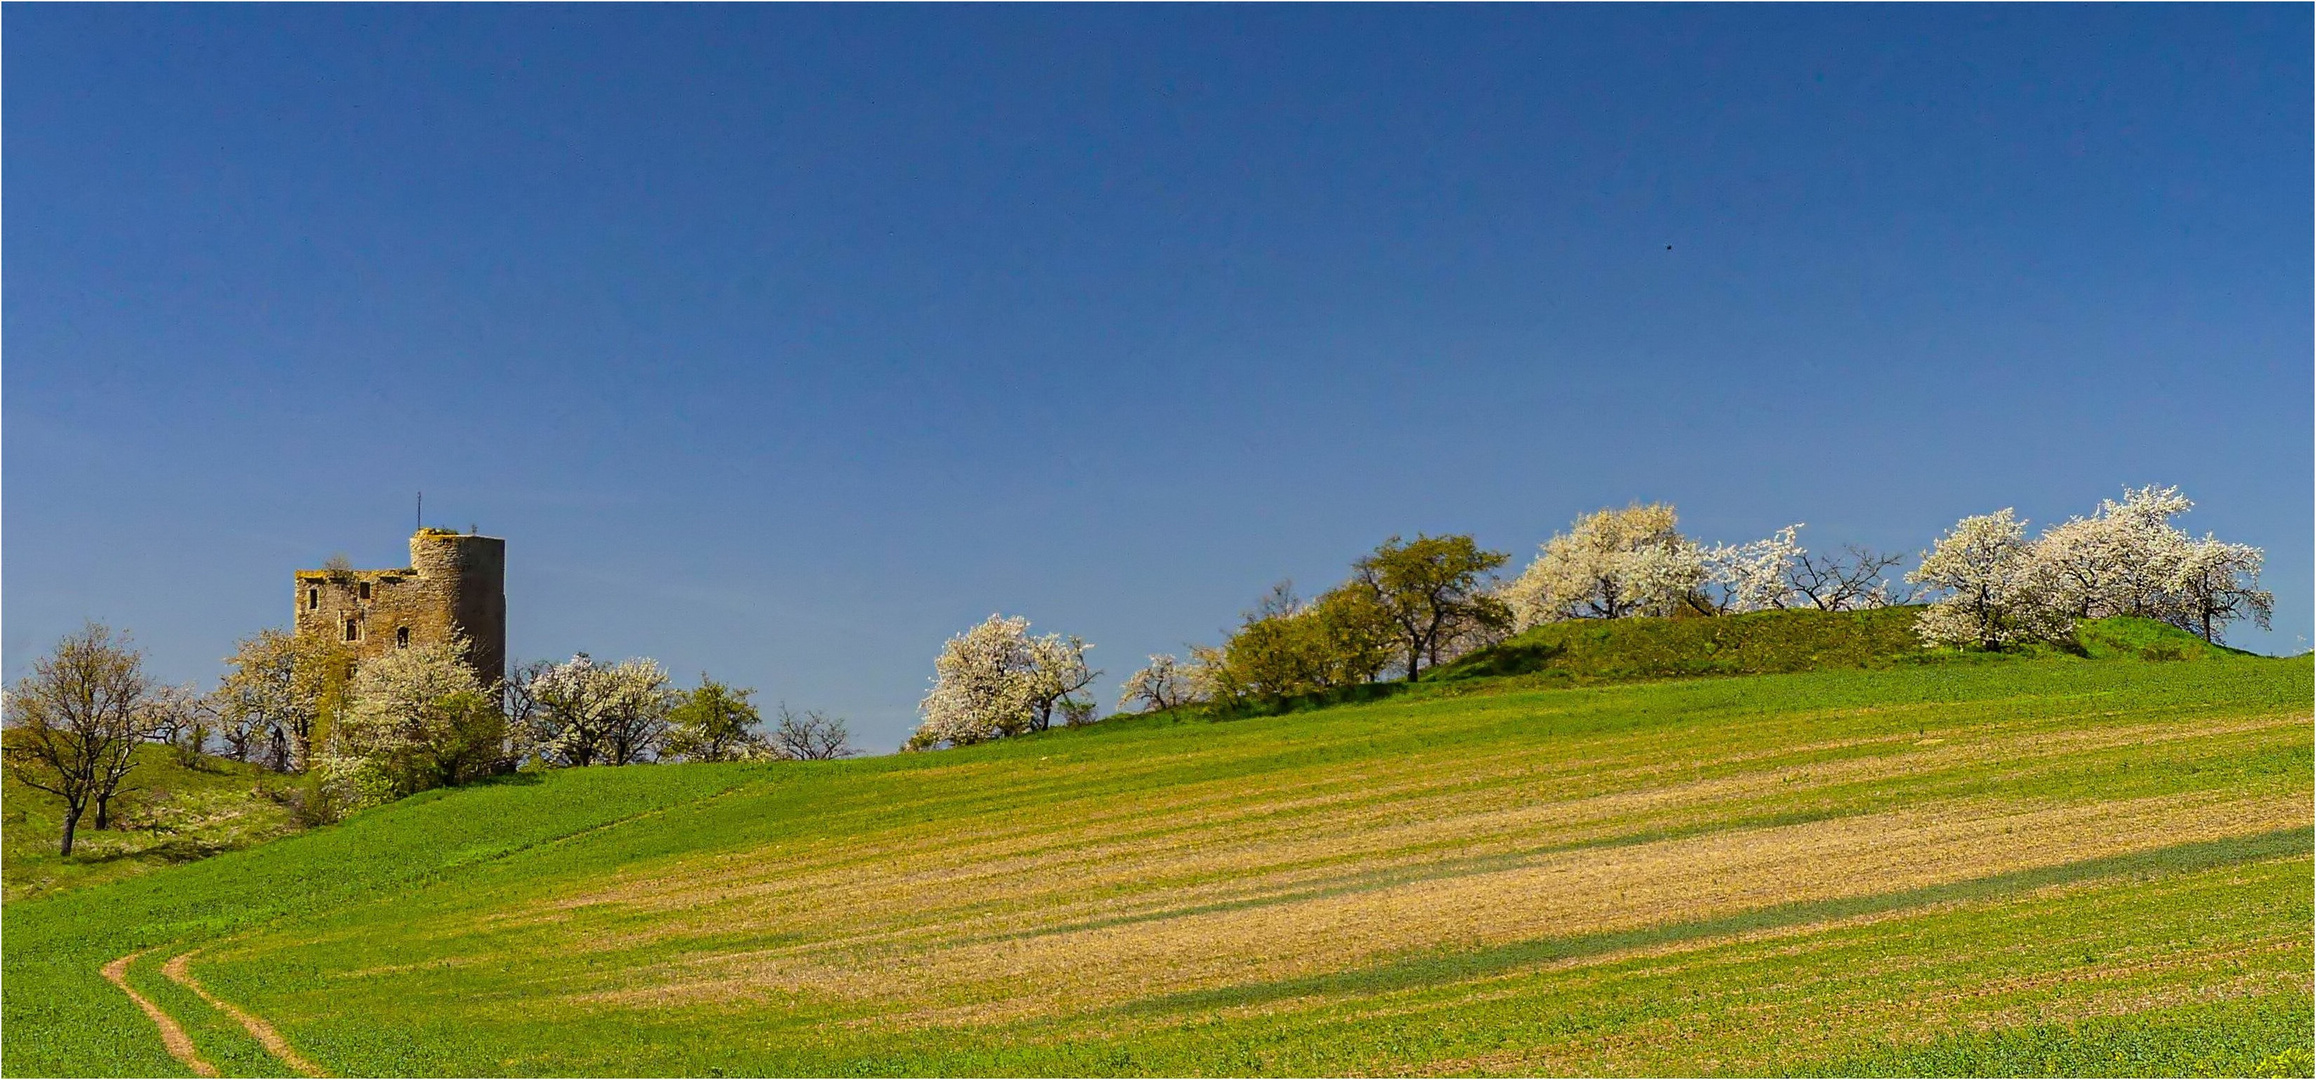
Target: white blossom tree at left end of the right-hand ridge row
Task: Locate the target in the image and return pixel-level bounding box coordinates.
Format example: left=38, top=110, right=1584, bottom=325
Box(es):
left=906, top=614, right=1100, bottom=749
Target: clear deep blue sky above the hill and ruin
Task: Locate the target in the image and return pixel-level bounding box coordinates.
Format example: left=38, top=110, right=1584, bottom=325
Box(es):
left=0, top=5, right=2311, bottom=746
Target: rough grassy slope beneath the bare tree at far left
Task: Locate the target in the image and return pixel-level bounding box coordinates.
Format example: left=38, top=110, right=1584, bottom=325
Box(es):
left=0, top=746, right=294, bottom=902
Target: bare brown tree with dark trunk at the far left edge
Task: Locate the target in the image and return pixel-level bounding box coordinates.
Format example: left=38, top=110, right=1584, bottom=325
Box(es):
left=5, top=623, right=153, bottom=855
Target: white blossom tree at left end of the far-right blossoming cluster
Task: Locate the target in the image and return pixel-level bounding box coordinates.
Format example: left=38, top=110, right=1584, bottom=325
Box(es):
left=1906, top=508, right=2073, bottom=649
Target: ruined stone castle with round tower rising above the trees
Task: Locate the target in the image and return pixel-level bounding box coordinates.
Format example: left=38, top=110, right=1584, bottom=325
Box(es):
left=296, top=528, right=507, bottom=686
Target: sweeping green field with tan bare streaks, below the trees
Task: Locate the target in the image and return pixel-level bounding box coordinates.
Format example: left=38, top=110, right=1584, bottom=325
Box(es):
left=0, top=644, right=2316, bottom=1075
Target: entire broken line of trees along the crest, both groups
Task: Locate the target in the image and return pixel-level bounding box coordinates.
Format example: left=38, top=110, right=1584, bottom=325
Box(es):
left=0, top=487, right=2274, bottom=838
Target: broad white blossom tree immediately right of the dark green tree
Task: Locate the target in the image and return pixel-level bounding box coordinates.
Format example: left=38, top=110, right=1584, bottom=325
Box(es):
left=1503, top=503, right=1705, bottom=630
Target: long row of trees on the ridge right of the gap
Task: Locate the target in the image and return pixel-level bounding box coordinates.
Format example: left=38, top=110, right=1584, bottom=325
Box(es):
left=908, top=487, right=2274, bottom=749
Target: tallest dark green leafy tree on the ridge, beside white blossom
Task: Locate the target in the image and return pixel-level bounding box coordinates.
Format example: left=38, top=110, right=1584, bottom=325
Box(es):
left=1353, top=533, right=1512, bottom=681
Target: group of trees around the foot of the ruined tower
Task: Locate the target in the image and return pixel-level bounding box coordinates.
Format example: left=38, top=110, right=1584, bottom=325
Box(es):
left=0, top=623, right=855, bottom=855
